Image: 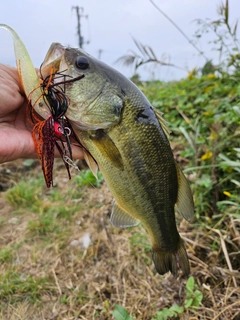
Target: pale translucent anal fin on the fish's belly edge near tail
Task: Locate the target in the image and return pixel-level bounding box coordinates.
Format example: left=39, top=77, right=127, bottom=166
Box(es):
left=110, top=200, right=140, bottom=228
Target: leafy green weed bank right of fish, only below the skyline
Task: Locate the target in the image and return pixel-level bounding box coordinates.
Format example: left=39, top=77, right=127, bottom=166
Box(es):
left=141, top=74, right=240, bottom=218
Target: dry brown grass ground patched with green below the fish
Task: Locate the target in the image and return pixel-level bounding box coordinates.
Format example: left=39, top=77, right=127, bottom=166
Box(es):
left=0, top=161, right=240, bottom=320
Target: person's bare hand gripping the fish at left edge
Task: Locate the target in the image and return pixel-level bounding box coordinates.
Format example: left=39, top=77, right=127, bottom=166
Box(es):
left=0, top=64, right=83, bottom=163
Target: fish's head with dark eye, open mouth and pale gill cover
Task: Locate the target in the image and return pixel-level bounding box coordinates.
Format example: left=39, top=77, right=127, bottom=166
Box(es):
left=41, top=43, right=124, bottom=130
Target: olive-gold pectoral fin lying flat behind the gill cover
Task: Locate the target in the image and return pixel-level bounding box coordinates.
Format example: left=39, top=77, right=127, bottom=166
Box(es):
left=91, top=130, right=124, bottom=171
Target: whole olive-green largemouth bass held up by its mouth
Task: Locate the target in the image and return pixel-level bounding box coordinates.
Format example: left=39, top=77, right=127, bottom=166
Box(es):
left=44, top=43, right=194, bottom=275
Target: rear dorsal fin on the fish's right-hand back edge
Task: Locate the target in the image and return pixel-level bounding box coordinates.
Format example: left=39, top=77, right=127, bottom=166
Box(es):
left=176, top=163, right=194, bottom=221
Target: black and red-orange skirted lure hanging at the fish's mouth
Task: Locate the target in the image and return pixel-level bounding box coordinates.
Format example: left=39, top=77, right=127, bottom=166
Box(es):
left=31, top=69, right=84, bottom=188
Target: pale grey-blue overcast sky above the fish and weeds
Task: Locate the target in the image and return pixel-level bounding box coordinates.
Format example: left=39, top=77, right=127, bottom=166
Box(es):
left=0, top=0, right=240, bottom=81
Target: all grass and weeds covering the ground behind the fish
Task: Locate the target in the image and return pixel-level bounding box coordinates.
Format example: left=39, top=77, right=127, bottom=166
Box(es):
left=0, top=1, right=240, bottom=320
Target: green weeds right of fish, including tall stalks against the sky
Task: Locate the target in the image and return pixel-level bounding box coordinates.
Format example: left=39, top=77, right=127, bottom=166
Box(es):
left=135, top=0, right=240, bottom=222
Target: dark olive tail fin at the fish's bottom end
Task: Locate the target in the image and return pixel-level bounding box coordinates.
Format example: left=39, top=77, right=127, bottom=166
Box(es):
left=152, top=238, right=190, bottom=276
